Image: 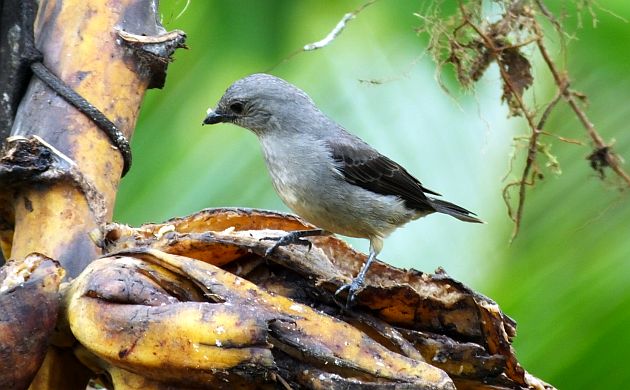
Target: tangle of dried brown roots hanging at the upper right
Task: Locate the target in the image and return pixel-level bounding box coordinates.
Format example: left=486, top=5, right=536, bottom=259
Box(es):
left=416, top=0, right=630, bottom=239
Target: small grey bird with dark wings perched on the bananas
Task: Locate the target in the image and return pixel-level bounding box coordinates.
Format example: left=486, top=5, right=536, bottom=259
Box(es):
left=203, top=74, right=482, bottom=303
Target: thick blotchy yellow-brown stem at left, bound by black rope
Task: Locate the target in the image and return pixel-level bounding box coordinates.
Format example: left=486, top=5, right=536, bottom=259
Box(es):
left=0, top=0, right=181, bottom=389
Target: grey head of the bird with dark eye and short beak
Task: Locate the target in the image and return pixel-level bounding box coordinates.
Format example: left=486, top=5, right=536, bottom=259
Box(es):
left=203, top=73, right=317, bottom=135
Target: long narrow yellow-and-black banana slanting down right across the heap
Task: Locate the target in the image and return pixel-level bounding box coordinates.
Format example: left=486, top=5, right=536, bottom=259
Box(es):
left=136, top=250, right=454, bottom=389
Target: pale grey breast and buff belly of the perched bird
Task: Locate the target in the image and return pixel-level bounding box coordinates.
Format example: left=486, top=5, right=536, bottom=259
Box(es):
left=261, top=137, right=415, bottom=238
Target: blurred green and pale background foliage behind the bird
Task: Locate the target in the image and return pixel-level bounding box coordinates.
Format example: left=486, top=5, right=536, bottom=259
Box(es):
left=115, top=0, right=630, bottom=389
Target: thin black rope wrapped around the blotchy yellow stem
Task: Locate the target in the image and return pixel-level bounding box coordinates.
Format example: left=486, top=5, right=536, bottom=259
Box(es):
left=22, top=1, right=131, bottom=176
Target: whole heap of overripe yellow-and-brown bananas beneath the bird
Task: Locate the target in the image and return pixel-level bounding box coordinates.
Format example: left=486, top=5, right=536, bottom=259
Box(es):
left=66, top=208, right=552, bottom=389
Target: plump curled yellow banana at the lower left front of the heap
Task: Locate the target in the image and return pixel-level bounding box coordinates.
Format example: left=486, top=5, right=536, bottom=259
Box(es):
left=68, top=258, right=274, bottom=383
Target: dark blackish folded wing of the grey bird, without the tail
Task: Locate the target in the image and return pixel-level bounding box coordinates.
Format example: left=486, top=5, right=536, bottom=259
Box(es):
left=327, top=134, right=440, bottom=211
